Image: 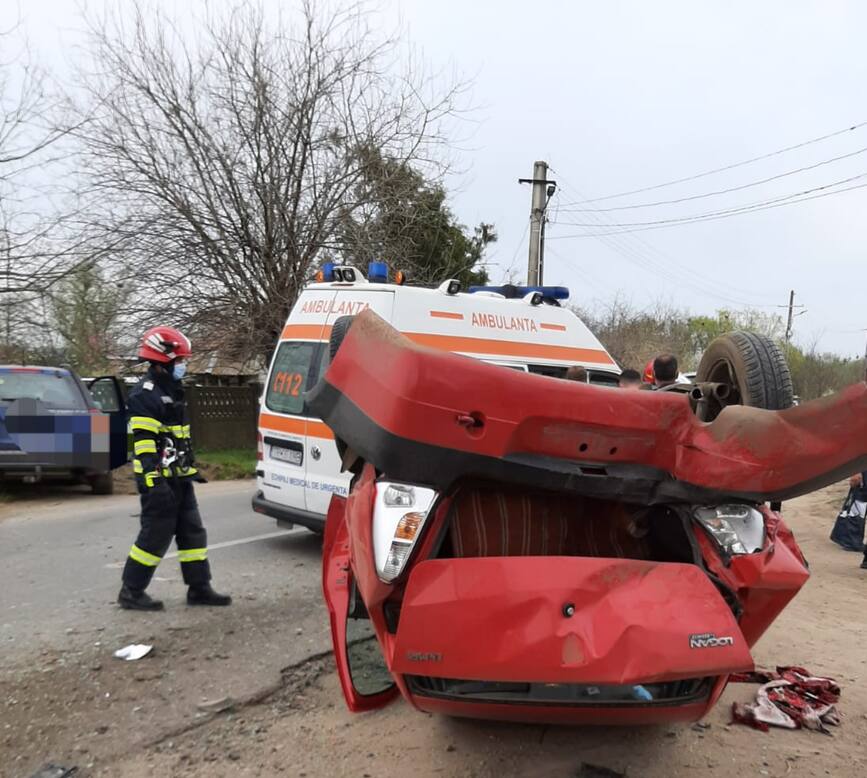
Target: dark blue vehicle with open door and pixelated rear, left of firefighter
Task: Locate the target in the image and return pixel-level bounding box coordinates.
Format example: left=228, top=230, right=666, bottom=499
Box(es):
left=0, top=365, right=128, bottom=494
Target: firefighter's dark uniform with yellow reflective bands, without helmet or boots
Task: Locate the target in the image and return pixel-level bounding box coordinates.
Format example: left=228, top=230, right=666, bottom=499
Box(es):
left=123, top=367, right=211, bottom=592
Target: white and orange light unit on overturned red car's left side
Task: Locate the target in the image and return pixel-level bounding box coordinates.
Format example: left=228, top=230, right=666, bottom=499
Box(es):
left=373, top=481, right=436, bottom=583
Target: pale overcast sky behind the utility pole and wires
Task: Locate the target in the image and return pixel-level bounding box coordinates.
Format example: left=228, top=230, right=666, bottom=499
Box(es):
left=13, top=0, right=867, bottom=355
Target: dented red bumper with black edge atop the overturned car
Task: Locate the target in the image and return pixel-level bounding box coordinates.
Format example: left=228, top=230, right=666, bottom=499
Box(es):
left=308, top=311, right=867, bottom=504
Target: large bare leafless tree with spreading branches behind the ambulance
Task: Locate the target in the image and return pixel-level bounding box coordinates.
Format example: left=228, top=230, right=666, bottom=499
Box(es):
left=74, top=3, right=461, bottom=355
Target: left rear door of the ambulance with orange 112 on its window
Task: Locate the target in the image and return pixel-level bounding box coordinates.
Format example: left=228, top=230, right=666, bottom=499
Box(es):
left=259, top=289, right=335, bottom=512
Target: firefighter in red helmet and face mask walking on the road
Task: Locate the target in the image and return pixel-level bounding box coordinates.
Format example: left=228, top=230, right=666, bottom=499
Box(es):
left=117, top=327, right=232, bottom=611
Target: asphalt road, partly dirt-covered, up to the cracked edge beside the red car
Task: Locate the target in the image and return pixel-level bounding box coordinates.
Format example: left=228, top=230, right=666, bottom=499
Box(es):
left=0, top=481, right=331, bottom=775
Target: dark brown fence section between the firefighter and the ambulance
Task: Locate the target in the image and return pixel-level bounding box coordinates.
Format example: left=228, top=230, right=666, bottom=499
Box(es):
left=185, top=385, right=261, bottom=450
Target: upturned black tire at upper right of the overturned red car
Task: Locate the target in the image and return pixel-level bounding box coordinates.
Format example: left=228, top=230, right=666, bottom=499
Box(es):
left=696, top=332, right=794, bottom=411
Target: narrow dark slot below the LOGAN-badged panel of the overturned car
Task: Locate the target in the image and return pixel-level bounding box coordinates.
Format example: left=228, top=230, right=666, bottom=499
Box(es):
left=404, top=675, right=715, bottom=707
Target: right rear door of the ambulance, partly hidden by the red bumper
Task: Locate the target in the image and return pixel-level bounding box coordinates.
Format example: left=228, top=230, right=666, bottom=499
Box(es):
left=304, top=287, right=394, bottom=516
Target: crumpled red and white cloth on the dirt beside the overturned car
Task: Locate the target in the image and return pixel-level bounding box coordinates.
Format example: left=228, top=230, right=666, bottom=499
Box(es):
left=731, top=667, right=840, bottom=735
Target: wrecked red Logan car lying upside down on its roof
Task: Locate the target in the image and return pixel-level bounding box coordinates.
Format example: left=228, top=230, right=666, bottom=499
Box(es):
left=309, top=312, right=867, bottom=724
